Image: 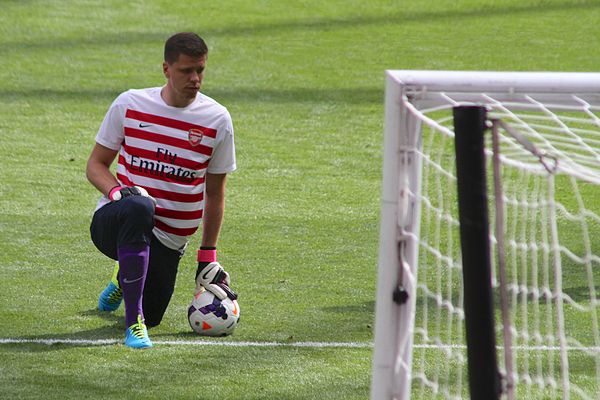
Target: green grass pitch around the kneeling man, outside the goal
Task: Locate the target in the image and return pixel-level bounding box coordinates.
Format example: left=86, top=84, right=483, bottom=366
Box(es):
left=0, top=0, right=600, bottom=400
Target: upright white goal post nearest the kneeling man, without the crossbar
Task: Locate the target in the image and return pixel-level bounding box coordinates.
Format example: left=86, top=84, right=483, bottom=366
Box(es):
left=371, top=69, right=421, bottom=399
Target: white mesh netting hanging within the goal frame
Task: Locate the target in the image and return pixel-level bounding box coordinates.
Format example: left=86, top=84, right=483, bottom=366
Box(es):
left=404, top=92, right=600, bottom=399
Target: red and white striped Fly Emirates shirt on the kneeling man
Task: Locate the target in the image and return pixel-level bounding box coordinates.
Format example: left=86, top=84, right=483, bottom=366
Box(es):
left=96, top=87, right=236, bottom=249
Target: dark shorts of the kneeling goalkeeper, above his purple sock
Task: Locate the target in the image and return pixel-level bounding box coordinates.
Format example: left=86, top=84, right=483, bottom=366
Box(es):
left=90, top=196, right=183, bottom=327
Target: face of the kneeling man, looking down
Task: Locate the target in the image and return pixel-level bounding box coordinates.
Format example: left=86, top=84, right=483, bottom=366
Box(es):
left=163, top=54, right=206, bottom=101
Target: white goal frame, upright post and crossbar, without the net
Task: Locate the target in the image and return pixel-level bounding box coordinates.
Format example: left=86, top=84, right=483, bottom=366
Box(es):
left=371, top=70, right=600, bottom=400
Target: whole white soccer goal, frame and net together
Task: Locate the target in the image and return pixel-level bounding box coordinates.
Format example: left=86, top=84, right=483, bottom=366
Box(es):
left=371, top=71, right=600, bottom=400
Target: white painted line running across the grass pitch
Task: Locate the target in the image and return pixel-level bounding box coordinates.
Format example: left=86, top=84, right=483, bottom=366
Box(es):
left=0, top=338, right=600, bottom=353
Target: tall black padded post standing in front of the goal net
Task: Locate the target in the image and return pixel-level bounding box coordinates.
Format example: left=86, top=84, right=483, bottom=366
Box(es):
left=454, top=106, right=501, bottom=400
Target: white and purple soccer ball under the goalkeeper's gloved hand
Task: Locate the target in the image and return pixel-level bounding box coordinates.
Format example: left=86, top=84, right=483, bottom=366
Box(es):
left=188, top=290, right=240, bottom=336
